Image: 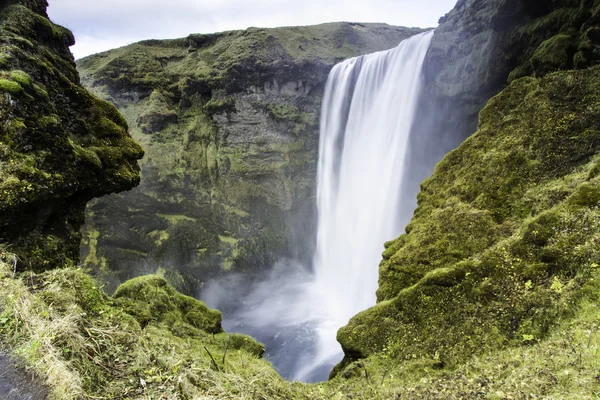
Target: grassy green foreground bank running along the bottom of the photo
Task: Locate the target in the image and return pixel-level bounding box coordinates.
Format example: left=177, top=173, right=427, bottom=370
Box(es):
left=0, top=258, right=600, bottom=400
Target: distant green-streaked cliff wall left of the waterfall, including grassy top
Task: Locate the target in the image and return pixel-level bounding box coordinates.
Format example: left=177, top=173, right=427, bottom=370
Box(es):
left=78, top=23, right=420, bottom=292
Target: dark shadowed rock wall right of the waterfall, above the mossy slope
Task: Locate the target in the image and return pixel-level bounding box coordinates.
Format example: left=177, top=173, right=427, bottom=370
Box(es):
left=406, top=0, right=600, bottom=211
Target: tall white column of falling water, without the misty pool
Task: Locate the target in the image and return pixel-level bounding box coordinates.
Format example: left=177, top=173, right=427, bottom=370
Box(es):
left=302, top=32, right=433, bottom=376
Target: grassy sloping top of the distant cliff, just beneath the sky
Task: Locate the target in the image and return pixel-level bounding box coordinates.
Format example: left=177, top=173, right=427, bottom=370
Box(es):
left=78, top=22, right=423, bottom=94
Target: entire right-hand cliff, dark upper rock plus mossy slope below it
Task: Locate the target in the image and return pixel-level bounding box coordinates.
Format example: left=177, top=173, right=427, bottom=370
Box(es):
left=338, top=1, right=600, bottom=378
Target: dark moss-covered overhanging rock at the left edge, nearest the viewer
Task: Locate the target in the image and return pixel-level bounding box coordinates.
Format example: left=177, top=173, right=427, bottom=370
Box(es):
left=0, top=0, right=143, bottom=270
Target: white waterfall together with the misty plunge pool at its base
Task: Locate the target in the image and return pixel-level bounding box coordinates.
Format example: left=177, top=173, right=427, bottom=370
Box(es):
left=203, top=32, right=433, bottom=381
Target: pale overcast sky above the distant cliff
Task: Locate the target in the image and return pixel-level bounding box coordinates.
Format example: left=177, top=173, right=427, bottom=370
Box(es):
left=48, top=0, right=456, bottom=58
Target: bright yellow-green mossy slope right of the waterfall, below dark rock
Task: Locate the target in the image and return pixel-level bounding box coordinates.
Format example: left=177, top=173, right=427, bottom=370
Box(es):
left=338, top=67, right=600, bottom=371
